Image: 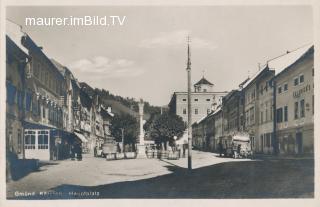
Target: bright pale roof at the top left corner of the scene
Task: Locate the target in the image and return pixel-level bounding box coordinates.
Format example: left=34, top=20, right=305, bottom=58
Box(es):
left=6, top=20, right=29, bottom=54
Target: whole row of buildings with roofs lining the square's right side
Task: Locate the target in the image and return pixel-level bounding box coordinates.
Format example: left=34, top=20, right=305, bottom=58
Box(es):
left=192, top=45, right=314, bottom=154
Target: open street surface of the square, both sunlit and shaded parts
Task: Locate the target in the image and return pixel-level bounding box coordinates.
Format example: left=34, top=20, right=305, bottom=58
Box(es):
left=7, top=151, right=314, bottom=199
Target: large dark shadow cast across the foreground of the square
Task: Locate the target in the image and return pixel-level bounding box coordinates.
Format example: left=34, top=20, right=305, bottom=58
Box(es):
left=13, top=159, right=314, bottom=199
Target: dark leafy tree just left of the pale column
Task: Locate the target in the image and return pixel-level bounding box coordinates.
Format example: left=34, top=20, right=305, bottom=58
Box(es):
left=110, top=113, right=139, bottom=144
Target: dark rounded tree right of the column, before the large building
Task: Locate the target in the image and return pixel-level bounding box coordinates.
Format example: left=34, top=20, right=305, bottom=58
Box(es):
left=148, top=113, right=186, bottom=150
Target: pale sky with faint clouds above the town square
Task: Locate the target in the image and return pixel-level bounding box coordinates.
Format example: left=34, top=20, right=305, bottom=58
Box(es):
left=6, top=6, right=313, bottom=106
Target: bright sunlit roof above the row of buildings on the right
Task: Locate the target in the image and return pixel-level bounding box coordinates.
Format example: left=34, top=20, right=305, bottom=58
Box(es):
left=267, top=44, right=313, bottom=75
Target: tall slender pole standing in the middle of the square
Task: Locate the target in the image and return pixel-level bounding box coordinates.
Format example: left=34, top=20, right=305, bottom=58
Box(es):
left=187, top=36, right=192, bottom=170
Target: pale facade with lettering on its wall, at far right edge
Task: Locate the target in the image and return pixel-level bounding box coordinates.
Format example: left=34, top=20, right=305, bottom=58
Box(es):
left=275, top=47, right=314, bottom=154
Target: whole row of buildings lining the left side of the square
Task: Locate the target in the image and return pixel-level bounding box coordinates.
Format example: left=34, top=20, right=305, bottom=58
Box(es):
left=6, top=21, right=113, bottom=160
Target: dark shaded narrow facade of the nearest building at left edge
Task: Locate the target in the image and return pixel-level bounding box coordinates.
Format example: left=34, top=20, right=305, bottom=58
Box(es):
left=6, top=36, right=30, bottom=159
